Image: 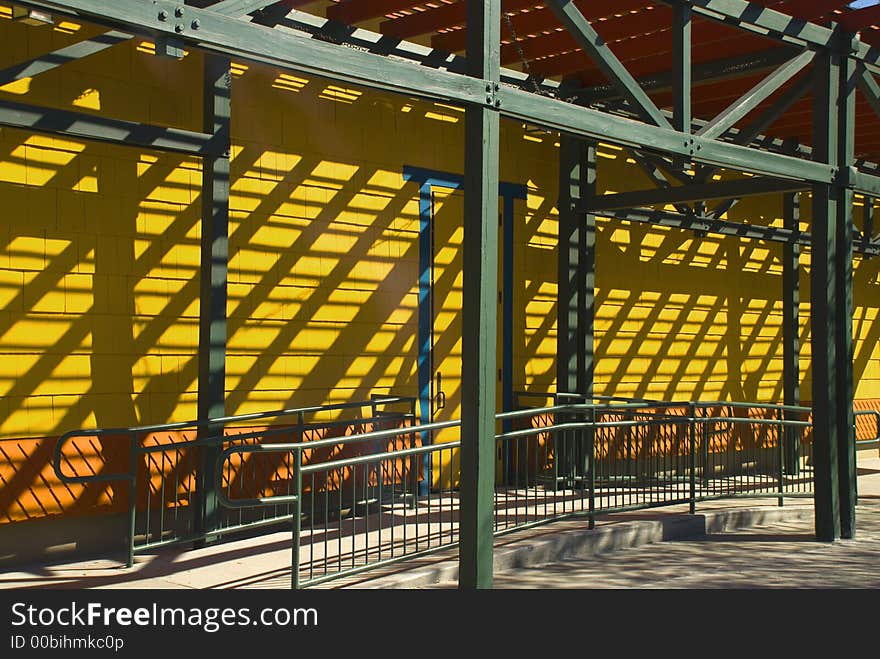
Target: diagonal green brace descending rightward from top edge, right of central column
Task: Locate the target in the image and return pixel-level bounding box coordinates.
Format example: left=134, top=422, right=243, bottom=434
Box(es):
left=546, top=0, right=671, bottom=128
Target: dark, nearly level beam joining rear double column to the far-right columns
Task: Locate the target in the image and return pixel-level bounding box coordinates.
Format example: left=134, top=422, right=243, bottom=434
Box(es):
left=580, top=176, right=809, bottom=212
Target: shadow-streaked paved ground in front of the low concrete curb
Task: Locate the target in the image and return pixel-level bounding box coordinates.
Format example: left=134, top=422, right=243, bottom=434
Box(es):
left=495, top=456, right=880, bottom=588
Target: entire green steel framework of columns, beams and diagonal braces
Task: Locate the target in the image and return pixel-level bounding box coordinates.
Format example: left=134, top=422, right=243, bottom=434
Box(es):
left=6, top=0, right=880, bottom=588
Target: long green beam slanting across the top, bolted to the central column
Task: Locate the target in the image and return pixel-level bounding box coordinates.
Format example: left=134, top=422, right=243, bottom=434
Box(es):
left=17, top=0, right=835, bottom=183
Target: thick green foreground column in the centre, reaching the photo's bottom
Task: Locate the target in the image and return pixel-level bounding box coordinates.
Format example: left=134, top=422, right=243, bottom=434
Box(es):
left=458, top=0, right=501, bottom=590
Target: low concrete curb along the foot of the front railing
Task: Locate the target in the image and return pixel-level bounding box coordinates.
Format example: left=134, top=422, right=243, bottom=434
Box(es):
left=349, top=506, right=814, bottom=589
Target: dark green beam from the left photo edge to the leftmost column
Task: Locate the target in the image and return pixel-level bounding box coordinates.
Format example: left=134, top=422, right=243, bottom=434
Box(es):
left=0, top=100, right=223, bottom=156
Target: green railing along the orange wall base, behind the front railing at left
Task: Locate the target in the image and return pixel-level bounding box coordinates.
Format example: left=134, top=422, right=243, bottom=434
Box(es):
left=52, top=395, right=415, bottom=566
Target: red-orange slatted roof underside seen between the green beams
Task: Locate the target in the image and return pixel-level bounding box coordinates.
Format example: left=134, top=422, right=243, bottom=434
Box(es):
left=287, top=0, right=880, bottom=162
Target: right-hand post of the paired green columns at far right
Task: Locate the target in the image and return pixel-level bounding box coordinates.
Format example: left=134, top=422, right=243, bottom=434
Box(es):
left=833, top=41, right=857, bottom=538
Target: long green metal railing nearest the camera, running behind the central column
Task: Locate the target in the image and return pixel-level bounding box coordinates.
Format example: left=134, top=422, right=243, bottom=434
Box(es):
left=216, top=401, right=844, bottom=588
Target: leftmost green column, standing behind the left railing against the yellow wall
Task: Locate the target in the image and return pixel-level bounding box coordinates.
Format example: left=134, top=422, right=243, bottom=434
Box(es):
left=195, top=54, right=231, bottom=540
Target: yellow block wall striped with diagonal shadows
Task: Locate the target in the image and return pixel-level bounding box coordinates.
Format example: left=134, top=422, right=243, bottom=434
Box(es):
left=0, top=11, right=880, bottom=521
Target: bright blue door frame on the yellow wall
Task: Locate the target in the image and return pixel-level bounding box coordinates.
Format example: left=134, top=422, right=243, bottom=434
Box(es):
left=403, top=165, right=528, bottom=495
